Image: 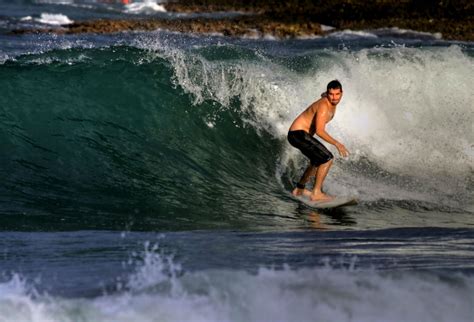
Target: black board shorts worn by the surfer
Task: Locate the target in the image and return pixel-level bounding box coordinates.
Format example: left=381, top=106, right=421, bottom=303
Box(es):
left=288, top=130, right=334, bottom=167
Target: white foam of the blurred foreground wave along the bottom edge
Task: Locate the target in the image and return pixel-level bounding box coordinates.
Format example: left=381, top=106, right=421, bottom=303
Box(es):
left=0, top=247, right=474, bottom=322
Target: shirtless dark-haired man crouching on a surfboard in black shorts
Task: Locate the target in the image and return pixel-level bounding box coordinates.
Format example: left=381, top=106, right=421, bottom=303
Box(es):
left=288, top=80, right=349, bottom=201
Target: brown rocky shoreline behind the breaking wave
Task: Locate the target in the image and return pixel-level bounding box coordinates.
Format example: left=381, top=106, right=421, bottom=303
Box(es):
left=13, top=0, right=474, bottom=41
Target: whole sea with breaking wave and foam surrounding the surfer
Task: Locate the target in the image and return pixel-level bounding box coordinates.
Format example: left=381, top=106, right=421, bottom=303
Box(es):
left=0, top=1, right=474, bottom=322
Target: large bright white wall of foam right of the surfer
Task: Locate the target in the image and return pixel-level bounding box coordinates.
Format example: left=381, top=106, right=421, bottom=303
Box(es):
left=331, top=46, right=474, bottom=177
